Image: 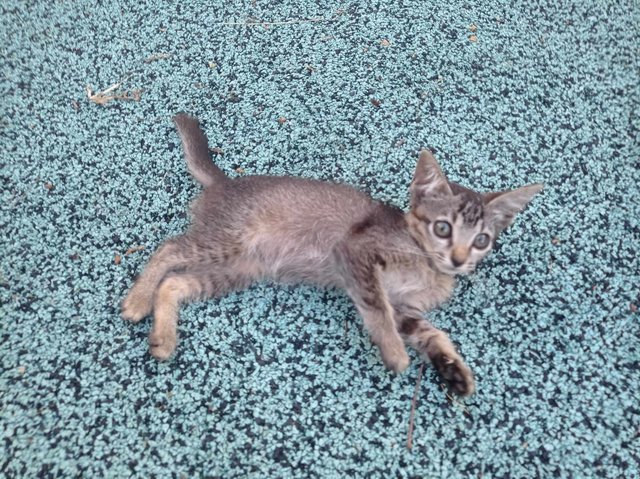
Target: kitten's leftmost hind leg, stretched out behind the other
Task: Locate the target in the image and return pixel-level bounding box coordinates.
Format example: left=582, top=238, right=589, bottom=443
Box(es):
left=121, top=236, right=192, bottom=323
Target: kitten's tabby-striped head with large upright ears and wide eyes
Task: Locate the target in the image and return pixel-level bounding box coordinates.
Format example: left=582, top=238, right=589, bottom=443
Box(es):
left=407, top=150, right=542, bottom=274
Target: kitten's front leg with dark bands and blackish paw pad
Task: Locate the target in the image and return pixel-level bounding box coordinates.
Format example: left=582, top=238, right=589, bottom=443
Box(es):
left=396, top=312, right=475, bottom=396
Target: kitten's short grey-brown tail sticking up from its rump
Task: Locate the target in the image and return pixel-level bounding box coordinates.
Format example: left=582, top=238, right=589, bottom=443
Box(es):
left=173, top=113, right=228, bottom=187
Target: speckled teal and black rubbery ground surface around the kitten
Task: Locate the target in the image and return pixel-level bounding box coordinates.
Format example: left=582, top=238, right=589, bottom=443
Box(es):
left=0, top=0, right=640, bottom=478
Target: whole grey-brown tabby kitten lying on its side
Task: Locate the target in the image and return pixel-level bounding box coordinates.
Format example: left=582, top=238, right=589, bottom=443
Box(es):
left=122, top=114, right=542, bottom=395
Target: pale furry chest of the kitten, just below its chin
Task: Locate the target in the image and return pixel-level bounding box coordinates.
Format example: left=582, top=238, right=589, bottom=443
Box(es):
left=382, top=265, right=455, bottom=311
